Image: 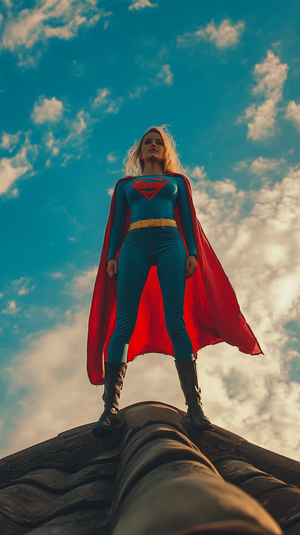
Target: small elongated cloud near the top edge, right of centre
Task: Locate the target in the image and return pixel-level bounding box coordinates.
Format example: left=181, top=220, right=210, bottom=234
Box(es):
left=177, top=20, right=245, bottom=48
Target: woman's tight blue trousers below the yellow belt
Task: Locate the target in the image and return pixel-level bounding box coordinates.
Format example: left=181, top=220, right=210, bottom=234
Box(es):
left=107, top=227, right=194, bottom=364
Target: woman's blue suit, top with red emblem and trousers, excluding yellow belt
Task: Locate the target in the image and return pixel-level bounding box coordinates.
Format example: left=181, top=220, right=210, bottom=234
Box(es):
left=107, top=175, right=197, bottom=364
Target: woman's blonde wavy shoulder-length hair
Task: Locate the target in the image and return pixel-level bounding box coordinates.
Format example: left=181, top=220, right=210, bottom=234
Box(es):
left=123, top=125, right=185, bottom=176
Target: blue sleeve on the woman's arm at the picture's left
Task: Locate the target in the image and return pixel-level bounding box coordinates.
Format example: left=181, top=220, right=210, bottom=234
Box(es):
left=107, top=182, right=128, bottom=260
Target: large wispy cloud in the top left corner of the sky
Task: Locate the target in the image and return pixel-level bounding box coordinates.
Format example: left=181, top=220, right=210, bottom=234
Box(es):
left=2, top=0, right=111, bottom=66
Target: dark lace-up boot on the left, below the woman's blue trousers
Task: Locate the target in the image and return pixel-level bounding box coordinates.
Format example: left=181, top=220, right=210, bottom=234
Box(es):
left=92, top=362, right=127, bottom=436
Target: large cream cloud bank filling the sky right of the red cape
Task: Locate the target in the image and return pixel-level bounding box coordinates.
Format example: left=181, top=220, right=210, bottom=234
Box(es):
left=190, top=166, right=300, bottom=458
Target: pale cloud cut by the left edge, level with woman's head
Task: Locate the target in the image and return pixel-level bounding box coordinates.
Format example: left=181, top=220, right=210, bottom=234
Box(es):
left=0, top=139, right=36, bottom=195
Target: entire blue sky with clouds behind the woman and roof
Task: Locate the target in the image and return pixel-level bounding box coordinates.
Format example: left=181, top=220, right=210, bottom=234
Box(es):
left=0, top=0, right=300, bottom=458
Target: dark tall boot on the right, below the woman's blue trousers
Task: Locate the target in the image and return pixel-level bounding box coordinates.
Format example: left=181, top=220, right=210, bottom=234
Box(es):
left=175, top=359, right=212, bottom=430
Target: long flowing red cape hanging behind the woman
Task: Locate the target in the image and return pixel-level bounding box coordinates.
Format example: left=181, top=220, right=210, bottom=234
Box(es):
left=87, top=173, right=262, bottom=385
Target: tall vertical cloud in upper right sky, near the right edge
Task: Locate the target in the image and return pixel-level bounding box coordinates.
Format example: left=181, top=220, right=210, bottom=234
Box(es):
left=244, top=50, right=289, bottom=141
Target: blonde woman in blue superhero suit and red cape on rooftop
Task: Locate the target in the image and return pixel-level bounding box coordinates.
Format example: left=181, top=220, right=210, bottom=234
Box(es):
left=88, top=127, right=262, bottom=435
